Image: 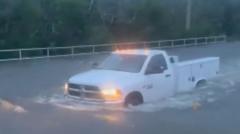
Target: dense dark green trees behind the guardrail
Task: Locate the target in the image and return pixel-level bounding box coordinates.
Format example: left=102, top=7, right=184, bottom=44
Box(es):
left=0, top=0, right=240, bottom=49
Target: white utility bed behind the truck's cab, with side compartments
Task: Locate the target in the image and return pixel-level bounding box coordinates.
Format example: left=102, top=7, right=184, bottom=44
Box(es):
left=175, top=57, right=219, bottom=92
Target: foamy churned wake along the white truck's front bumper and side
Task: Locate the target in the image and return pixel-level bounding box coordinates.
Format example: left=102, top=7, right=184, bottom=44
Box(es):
left=35, top=78, right=236, bottom=112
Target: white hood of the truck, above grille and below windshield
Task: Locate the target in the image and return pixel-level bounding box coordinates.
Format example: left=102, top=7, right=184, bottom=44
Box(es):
left=69, top=70, right=141, bottom=88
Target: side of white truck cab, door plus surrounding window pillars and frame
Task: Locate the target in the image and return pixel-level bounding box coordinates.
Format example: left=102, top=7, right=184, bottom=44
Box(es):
left=137, top=50, right=175, bottom=101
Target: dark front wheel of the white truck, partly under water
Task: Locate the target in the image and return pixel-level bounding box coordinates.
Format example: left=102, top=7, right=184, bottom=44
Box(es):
left=124, top=92, right=143, bottom=107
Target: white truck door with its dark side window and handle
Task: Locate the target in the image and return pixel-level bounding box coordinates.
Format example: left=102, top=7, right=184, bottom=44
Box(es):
left=144, top=54, right=174, bottom=101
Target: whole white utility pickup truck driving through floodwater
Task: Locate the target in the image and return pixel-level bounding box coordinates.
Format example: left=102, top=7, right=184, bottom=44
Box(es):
left=64, top=49, right=219, bottom=106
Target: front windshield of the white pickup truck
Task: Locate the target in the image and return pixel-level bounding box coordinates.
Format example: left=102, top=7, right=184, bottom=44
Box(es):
left=97, top=54, right=147, bottom=73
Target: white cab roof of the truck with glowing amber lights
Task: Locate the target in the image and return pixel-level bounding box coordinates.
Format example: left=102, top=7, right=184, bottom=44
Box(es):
left=113, top=49, right=164, bottom=56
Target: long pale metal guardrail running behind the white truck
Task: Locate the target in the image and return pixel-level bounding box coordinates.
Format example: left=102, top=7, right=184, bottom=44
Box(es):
left=0, top=35, right=226, bottom=61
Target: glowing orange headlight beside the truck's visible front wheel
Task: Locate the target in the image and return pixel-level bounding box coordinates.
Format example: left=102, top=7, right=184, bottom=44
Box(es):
left=101, top=89, right=122, bottom=101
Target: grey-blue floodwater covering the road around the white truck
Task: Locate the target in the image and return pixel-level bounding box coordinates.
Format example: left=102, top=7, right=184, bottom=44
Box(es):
left=0, top=42, right=240, bottom=134
